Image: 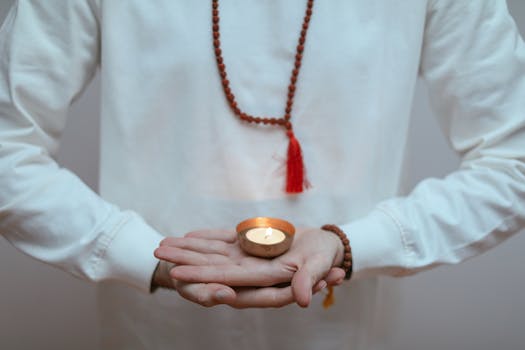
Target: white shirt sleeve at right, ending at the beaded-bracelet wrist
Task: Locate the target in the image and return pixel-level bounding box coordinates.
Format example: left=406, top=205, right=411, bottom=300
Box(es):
left=342, top=0, right=525, bottom=278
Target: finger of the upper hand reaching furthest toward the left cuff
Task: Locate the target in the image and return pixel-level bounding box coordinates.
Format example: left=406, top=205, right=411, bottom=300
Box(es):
left=153, top=246, right=231, bottom=265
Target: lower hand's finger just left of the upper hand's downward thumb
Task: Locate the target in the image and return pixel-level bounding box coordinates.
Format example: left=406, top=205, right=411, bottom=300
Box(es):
left=230, top=286, right=294, bottom=309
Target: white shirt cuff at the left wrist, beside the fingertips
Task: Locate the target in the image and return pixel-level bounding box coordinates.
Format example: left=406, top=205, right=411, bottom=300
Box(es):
left=91, top=212, right=164, bottom=293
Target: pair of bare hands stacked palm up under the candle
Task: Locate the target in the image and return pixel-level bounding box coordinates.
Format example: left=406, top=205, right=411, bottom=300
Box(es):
left=155, top=229, right=344, bottom=308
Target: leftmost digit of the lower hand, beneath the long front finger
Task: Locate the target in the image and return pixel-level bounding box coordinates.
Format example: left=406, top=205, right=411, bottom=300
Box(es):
left=175, top=281, right=236, bottom=307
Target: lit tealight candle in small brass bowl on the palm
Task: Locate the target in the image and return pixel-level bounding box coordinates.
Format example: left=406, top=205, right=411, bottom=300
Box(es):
left=237, top=217, right=295, bottom=258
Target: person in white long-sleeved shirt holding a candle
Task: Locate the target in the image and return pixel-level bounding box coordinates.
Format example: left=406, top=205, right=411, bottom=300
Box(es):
left=0, top=0, right=525, bottom=349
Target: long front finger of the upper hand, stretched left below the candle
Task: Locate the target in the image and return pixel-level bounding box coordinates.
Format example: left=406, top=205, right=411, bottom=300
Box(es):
left=171, top=259, right=293, bottom=287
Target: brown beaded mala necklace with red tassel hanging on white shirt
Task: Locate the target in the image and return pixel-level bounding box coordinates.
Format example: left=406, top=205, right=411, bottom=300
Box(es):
left=212, top=0, right=314, bottom=193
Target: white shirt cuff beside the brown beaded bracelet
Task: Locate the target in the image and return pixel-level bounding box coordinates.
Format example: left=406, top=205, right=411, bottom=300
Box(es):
left=340, top=208, right=411, bottom=280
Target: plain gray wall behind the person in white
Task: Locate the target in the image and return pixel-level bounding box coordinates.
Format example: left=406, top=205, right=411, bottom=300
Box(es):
left=0, top=0, right=525, bottom=350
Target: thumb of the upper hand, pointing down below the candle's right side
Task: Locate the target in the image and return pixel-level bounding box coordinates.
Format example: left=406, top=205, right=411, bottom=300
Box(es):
left=292, top=259, right=326, bottom=307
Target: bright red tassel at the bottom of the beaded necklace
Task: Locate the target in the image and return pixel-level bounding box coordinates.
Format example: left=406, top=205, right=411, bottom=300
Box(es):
left=286, top=130, right=306, bottom=193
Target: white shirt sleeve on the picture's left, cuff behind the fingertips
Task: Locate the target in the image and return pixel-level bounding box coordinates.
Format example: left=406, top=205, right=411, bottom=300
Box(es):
left=0, top=0, right=162, bottom=292
